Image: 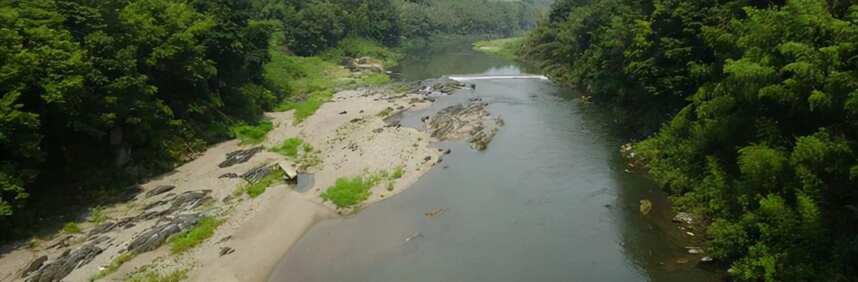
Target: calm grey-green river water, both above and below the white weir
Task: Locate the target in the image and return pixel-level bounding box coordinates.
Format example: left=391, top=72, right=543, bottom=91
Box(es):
left=270, top=38, right=720, bottom=282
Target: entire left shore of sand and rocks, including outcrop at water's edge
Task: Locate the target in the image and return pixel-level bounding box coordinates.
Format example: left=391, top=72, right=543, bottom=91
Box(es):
left=0, top=76, right=503, bottom=281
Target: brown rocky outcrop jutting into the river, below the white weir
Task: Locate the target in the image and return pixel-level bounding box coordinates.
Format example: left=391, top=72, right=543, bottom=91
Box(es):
left=427, top=102, right=503, bottom=151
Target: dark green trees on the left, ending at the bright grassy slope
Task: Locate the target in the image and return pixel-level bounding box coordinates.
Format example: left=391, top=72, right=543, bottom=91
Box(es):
left=0, top=0, right=276, bottom=238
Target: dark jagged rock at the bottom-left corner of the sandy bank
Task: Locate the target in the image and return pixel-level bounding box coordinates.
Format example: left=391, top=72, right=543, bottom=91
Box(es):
left=27, top=244, right=104, bottom=282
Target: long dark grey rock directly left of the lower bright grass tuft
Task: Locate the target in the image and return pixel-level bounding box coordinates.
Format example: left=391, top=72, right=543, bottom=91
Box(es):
left=126, top=214, right=200, bottom=254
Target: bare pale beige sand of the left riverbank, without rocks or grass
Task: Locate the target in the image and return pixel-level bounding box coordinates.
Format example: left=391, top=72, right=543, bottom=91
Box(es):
left=0, top=85, right=452, bottom=281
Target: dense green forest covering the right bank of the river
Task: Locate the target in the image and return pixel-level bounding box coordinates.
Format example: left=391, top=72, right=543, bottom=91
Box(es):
left=521, top=0, right=858, bottom=281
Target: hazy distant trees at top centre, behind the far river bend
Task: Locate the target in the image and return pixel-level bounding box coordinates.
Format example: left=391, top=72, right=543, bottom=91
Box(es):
left=257, top=0, right=548, bottom=55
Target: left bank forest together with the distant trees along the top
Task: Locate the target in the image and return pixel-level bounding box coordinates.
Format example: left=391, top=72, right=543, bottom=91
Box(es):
left=0, top=0, right=545, bottom=240
